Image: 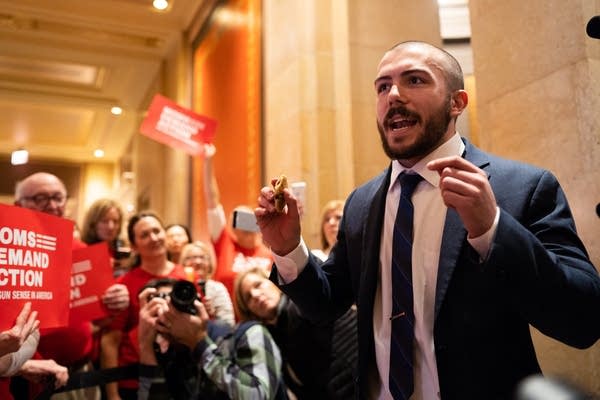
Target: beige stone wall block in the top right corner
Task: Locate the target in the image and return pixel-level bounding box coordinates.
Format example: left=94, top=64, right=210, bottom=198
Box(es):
left=469, top=0, right=592, bottom=103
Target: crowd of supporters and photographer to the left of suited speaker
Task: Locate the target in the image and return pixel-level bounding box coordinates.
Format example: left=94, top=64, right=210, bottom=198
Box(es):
left=0, top=139, right=356, bottom=400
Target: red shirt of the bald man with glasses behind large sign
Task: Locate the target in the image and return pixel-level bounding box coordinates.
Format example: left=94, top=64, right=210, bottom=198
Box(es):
left=37, top=238, right=94, bottom=367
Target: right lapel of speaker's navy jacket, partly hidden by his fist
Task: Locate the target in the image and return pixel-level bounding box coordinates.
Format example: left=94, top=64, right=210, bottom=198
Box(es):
left=434, top=138, right=490, bottom=320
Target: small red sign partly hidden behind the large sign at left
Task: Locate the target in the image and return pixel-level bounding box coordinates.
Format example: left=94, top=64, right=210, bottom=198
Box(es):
left=69, top=242, right=114, bottom=321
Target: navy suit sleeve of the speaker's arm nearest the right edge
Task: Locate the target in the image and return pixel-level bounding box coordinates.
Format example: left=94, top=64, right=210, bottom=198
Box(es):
left=484, top=171, right=600, bottom=348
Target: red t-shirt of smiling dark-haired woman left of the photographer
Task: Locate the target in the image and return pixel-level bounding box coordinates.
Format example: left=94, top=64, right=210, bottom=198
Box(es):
left=109, top=264, right=185, bottom=388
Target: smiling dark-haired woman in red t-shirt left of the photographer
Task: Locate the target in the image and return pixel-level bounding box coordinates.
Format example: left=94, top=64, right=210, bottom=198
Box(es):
left=100, top=212, right=185, bottom=400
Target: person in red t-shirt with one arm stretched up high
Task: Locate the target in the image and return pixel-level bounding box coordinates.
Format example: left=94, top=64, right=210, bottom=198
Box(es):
left=204, top=144, right=273, bottom=299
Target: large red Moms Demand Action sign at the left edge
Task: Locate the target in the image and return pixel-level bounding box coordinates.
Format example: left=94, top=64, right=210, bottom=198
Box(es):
left=0, top=204, right=73, bottom=331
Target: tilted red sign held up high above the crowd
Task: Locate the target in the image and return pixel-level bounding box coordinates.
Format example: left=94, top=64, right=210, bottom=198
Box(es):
left=140, top=94, right=217, bottom=156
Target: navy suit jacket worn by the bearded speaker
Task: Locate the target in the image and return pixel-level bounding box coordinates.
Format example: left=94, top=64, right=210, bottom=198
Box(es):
left=272, top=139, right=600, bottom=400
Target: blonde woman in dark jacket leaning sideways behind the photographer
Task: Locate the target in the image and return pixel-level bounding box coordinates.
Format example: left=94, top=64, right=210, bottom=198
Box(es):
left=235, top=268, right=358, bottom=400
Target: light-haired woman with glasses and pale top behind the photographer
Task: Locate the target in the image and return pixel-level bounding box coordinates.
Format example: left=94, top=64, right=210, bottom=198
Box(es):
left=181, top=241, right=235, bottom=326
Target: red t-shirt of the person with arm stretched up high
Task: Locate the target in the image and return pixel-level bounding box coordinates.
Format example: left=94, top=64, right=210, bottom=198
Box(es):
left=212, top=228, right=273, bottom=299
